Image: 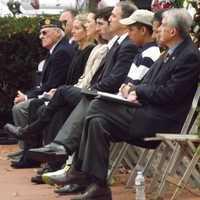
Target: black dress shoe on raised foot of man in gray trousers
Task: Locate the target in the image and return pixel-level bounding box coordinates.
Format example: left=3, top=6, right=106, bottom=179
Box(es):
left=28, top=143, right=68, bottom=162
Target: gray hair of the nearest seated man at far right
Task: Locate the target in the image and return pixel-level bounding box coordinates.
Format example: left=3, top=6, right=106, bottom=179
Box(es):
left=163, top=8, right=193, bottom=38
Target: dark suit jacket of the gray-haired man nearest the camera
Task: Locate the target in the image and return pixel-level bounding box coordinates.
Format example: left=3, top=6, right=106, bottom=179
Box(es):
left=130, top=38, right=200, bottom=141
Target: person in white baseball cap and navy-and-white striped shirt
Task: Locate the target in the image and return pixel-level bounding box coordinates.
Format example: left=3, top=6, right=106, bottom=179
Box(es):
left=120, top=9, right=160, bottom=85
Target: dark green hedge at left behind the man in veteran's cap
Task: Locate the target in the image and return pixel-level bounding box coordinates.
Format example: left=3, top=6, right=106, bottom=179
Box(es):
left=0, top=17, right=46, bottom=126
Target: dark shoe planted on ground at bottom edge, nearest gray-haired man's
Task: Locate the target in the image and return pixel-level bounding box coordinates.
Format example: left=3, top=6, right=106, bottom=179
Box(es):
left=71, top=183, right=112, bottom=200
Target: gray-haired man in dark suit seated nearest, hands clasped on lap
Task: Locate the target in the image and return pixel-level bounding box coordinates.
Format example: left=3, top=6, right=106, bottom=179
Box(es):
left=33, top=9, right=200, bottom=200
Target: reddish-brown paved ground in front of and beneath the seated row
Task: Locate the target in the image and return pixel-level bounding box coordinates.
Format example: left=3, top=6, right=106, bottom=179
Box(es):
left=0, top=145, right=200, bottom=200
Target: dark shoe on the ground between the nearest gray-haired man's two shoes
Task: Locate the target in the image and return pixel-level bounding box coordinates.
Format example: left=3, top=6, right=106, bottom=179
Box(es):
left=54, top=184, right=86, bottom=195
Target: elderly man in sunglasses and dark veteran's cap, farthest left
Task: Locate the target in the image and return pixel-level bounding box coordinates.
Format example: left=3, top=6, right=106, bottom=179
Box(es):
left=6, top=19, right=74, bottom=168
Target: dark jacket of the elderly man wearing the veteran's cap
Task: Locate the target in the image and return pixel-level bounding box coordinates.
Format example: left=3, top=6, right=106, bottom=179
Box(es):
left=27, top=38, right=74, bottom=98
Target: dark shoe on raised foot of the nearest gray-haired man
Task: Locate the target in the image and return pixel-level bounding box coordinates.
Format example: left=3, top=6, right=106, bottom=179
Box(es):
left=51, top=170, right=90, bottom=185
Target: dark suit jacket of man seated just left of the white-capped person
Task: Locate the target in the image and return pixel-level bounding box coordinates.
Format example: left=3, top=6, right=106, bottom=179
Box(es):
left=91, top=37, right=138, bottom=93
